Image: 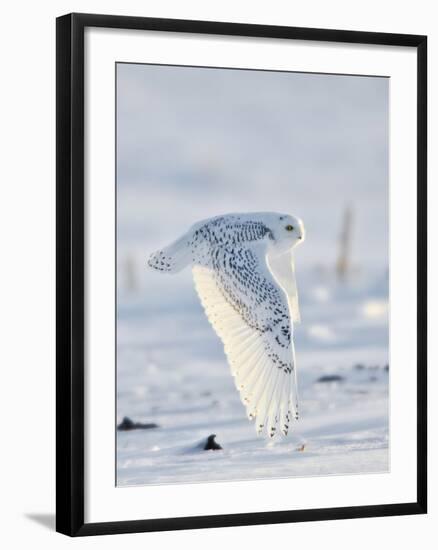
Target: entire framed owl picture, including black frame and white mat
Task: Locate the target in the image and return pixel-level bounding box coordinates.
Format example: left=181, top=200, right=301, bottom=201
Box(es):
left=56, top=14, right=427, bottom=536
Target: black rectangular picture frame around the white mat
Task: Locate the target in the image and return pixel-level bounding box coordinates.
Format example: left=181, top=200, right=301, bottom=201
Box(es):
left=56, top=13, right=427, bottom=536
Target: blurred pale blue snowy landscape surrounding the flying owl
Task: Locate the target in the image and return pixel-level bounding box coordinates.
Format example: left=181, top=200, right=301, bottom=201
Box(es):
left=116, top=64, right=389, bottom=485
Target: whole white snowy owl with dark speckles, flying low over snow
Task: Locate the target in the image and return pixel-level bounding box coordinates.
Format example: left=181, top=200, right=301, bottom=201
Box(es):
left=148, top=212, right=305, bottom=437
